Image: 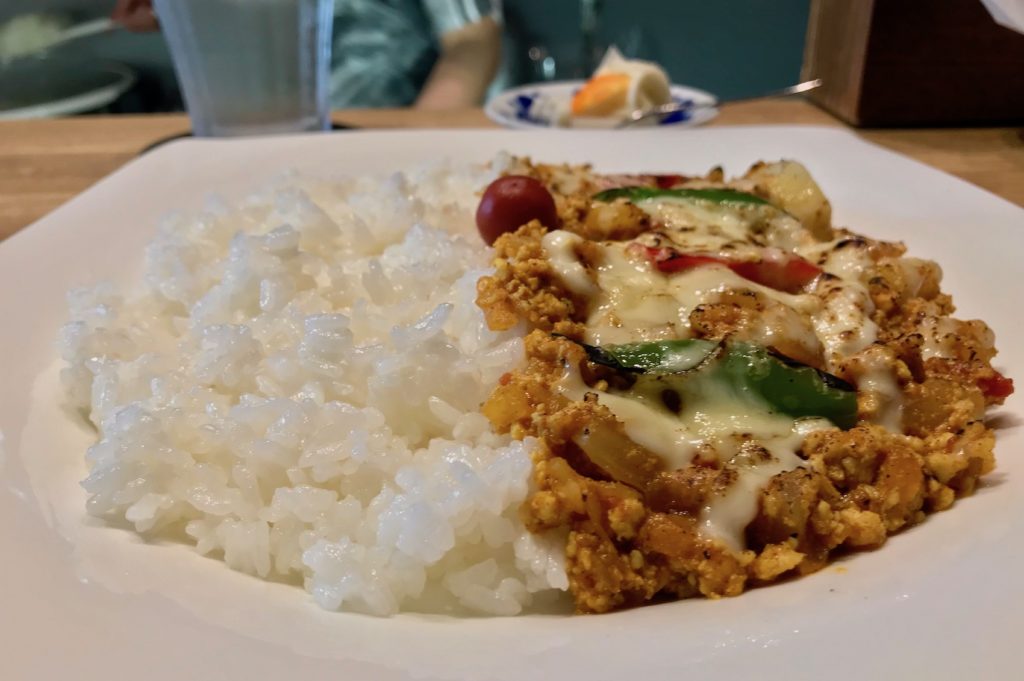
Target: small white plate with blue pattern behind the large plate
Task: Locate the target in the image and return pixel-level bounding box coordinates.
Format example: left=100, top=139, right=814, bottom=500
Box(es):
left=484, top=81, right=718, bottom=130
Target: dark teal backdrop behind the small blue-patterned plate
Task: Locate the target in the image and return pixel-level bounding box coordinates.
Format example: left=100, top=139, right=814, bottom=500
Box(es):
left=505, top=0, right=810, bottom=98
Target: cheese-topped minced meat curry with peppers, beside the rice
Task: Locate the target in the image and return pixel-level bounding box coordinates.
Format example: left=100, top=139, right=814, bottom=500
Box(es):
left=477, top=159, right=1013, bottom=612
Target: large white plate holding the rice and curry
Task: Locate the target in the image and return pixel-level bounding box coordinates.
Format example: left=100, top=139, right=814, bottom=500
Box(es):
left=0, top=127, right=1024, bottom=681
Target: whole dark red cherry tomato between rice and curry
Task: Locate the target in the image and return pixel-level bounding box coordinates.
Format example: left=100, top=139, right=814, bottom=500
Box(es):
left=476, top=175, right=558, bottom=246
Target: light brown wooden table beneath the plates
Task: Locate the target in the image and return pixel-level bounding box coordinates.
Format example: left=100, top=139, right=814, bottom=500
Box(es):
left=0, top=99, right=1024, bottom=239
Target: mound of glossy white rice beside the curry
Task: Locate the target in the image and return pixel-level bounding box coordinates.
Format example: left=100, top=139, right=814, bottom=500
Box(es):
left=59, top=159, right=567, bottom=614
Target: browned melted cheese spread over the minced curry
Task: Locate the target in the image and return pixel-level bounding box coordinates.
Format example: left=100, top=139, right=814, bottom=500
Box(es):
left=544, top=193, right=909, bottom=552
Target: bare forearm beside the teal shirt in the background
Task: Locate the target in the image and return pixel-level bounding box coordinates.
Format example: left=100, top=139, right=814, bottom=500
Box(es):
left=415, top=16, right=502, bottom=109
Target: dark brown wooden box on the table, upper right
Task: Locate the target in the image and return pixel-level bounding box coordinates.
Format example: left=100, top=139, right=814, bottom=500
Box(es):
left=802, top=0, right=1024, bottom=126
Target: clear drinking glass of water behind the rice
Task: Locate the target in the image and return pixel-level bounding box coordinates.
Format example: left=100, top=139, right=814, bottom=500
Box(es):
left=156, top=0, right=334, bottom=137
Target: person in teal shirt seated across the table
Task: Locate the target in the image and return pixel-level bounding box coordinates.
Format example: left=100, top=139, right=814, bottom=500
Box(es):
left=111, top=0, right=501, bottom=109
